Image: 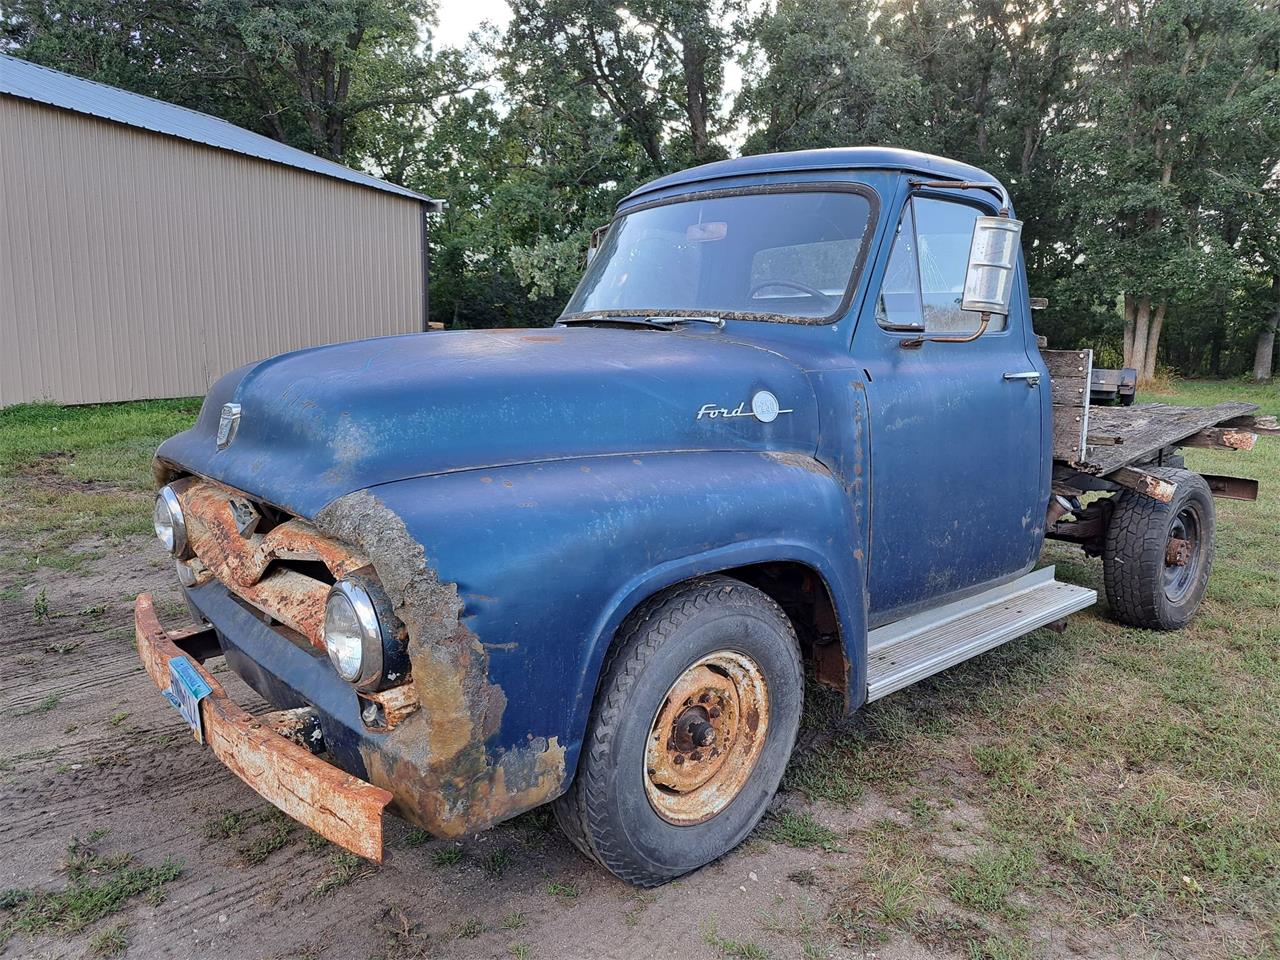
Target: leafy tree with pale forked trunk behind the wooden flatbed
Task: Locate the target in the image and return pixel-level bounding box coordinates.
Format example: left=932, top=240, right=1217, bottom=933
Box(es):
left=1069, top=0, right=1275, bottom=380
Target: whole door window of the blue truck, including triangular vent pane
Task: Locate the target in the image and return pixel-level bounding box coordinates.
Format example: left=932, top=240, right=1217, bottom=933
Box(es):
left=876, top=197, right=1007, bottom=334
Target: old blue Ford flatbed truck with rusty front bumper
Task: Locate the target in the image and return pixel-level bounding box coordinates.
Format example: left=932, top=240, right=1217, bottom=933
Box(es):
left=136, top=148, right=1267, bottom=884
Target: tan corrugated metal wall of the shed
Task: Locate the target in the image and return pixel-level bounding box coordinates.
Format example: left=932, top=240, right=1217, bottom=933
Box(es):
left=0, top=96, right=424, bottom=406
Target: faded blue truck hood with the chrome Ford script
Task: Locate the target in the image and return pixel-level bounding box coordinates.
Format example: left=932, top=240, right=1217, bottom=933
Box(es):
left=157, top=328, right=818, bottom=517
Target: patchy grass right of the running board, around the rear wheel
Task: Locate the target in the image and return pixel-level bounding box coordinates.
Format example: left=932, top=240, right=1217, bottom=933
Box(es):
left=786, top=381, right=1280, bottom=960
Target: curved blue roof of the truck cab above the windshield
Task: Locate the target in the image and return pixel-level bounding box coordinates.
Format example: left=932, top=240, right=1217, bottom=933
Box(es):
left=622, top=147, right=998, bottom=205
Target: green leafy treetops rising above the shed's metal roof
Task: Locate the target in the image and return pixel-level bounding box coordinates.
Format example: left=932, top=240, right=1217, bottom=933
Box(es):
left=4, top=0, right=471, bottom=160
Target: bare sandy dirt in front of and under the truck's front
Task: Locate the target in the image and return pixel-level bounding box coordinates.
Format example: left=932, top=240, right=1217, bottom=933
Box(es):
left=0, top=540, right=972, bottom=960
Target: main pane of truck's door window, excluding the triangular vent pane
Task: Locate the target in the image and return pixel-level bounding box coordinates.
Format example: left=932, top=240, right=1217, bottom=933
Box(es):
left=911, top=197, right=1006, bottom=333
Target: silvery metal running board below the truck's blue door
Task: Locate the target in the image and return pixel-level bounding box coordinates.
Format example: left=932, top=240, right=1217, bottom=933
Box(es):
left=867, top=567, right=1098, bottom=701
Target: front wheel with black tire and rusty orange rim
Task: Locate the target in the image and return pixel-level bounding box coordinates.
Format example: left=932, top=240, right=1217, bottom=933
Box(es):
left=556, top=576, right=804, bottom=887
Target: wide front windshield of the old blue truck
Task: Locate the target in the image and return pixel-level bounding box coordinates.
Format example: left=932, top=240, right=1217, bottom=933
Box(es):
left=564, top=187, right=870, bottom=320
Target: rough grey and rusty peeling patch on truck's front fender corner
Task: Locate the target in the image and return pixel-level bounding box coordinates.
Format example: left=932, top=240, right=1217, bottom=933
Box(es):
left=315, top=490, right=566, bottom=836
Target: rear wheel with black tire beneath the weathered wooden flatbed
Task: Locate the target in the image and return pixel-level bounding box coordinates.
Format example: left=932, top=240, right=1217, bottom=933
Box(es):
left=1102, top=466, right=1213, bottom=630
